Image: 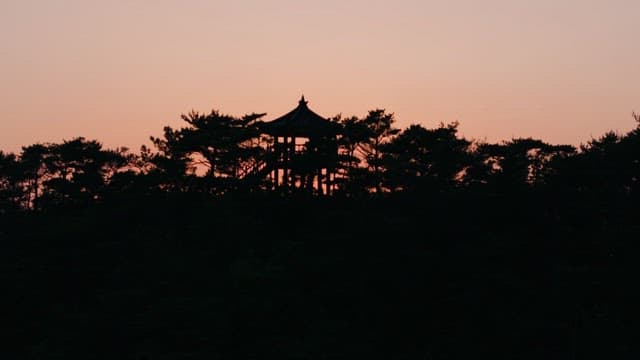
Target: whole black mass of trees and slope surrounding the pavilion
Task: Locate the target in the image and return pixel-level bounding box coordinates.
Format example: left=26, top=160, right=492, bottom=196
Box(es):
left=0, top=110, right=640, bottom=359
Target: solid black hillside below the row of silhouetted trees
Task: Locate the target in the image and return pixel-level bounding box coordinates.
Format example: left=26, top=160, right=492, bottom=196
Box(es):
left=0, top=193, right=640, bottom=360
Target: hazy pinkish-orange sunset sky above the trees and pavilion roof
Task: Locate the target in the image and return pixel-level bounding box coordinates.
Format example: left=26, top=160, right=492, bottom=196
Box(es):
left=0, top=0, right=640, bottom=152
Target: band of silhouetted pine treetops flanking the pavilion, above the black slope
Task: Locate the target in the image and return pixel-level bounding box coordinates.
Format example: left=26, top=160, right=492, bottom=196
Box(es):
left=0, top=105, right=640, bottom=211
